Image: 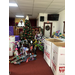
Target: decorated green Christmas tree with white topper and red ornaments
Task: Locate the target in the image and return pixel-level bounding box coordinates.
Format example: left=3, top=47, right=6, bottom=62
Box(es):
left=21, top=16, right=34, bottom=40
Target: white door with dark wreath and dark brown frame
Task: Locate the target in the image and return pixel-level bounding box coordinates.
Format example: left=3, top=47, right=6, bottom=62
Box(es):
left=44, top=22, right=52, bottom=37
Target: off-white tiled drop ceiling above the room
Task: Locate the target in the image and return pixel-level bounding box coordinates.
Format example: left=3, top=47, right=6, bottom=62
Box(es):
left=9, top=0, right=65, bottom=18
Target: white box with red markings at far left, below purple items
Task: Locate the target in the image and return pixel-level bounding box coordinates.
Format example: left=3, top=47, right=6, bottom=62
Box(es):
left=9, top=36, right=15, bottom=56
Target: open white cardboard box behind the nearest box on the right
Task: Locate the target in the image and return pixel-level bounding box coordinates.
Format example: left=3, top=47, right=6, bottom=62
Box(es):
left=44, top=38, right=62, bottom=67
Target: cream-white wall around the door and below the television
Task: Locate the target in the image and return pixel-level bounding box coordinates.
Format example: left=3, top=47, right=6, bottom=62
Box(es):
left=37, top=10, right=65, bottom=33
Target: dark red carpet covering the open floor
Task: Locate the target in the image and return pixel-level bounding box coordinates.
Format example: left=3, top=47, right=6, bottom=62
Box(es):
left=9, top=50, right=53, bottom=75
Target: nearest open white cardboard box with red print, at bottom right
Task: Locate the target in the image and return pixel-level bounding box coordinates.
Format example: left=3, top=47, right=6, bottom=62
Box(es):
left=51, top=42, right=65, bottom=75
